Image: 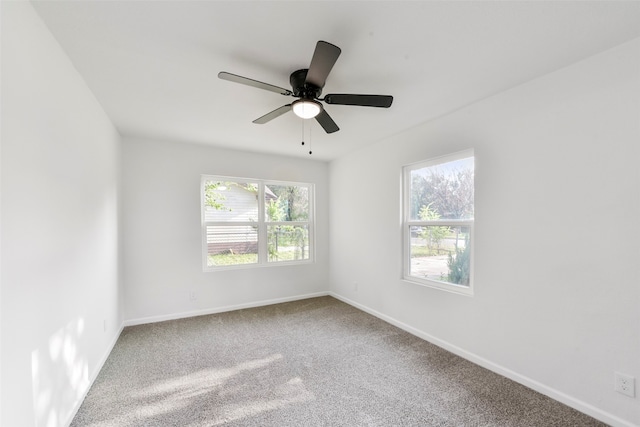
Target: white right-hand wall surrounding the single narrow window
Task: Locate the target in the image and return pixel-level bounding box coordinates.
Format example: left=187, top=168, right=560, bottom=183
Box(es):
left=330, top=40, right=640, bottom=425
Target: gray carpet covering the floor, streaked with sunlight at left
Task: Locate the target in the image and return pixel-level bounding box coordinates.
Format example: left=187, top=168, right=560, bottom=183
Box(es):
left=71, top=297, right=604, bottom=427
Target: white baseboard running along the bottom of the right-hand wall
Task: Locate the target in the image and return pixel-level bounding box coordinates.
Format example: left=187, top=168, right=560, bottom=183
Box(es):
left=329, top=292, right=639, bottom=427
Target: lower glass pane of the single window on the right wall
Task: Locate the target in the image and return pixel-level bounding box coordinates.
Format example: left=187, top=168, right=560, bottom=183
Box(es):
left=410, top=225, right=471, bottom=286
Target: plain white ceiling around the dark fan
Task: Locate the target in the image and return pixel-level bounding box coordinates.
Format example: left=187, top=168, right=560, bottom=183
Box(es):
left=33, top=1, right=640, bottom=160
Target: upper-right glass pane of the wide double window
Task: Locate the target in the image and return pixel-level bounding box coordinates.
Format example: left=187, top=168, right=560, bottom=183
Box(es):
left=264, top=184, right=309, bottom=222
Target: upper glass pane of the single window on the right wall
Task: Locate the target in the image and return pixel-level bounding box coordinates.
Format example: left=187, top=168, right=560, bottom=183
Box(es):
left=409, top=157, right=474, bottom=221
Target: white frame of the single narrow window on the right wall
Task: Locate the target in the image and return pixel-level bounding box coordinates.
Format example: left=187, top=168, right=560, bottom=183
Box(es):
left=402, top=149, right=475, bottom=296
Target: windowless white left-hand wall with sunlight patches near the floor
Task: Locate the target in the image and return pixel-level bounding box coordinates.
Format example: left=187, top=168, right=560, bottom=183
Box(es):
left=0, top=1, right=122, bottom=427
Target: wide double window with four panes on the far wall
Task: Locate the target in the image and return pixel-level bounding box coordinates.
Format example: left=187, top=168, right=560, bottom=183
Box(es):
left=201, top=175, right=313, bottom=271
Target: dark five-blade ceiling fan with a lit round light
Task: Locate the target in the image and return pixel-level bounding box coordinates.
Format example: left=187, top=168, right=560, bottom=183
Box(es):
left=218, top=40, right=393, bottom=133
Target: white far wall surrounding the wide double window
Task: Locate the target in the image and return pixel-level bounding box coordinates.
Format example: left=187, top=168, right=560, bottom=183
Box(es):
left=122, top=138, right=329, bottom=324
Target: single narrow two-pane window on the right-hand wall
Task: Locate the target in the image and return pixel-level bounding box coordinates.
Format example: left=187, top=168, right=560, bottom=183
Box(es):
left=403, top=151, right=474, bottom=294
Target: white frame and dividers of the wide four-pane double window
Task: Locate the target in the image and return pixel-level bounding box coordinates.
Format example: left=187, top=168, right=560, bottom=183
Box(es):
left=200, top=175, right=316, bottom=272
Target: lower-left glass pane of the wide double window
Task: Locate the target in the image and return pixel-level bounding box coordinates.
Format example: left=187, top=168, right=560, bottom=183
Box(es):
left=207, top=225, right=258, bottom=267
